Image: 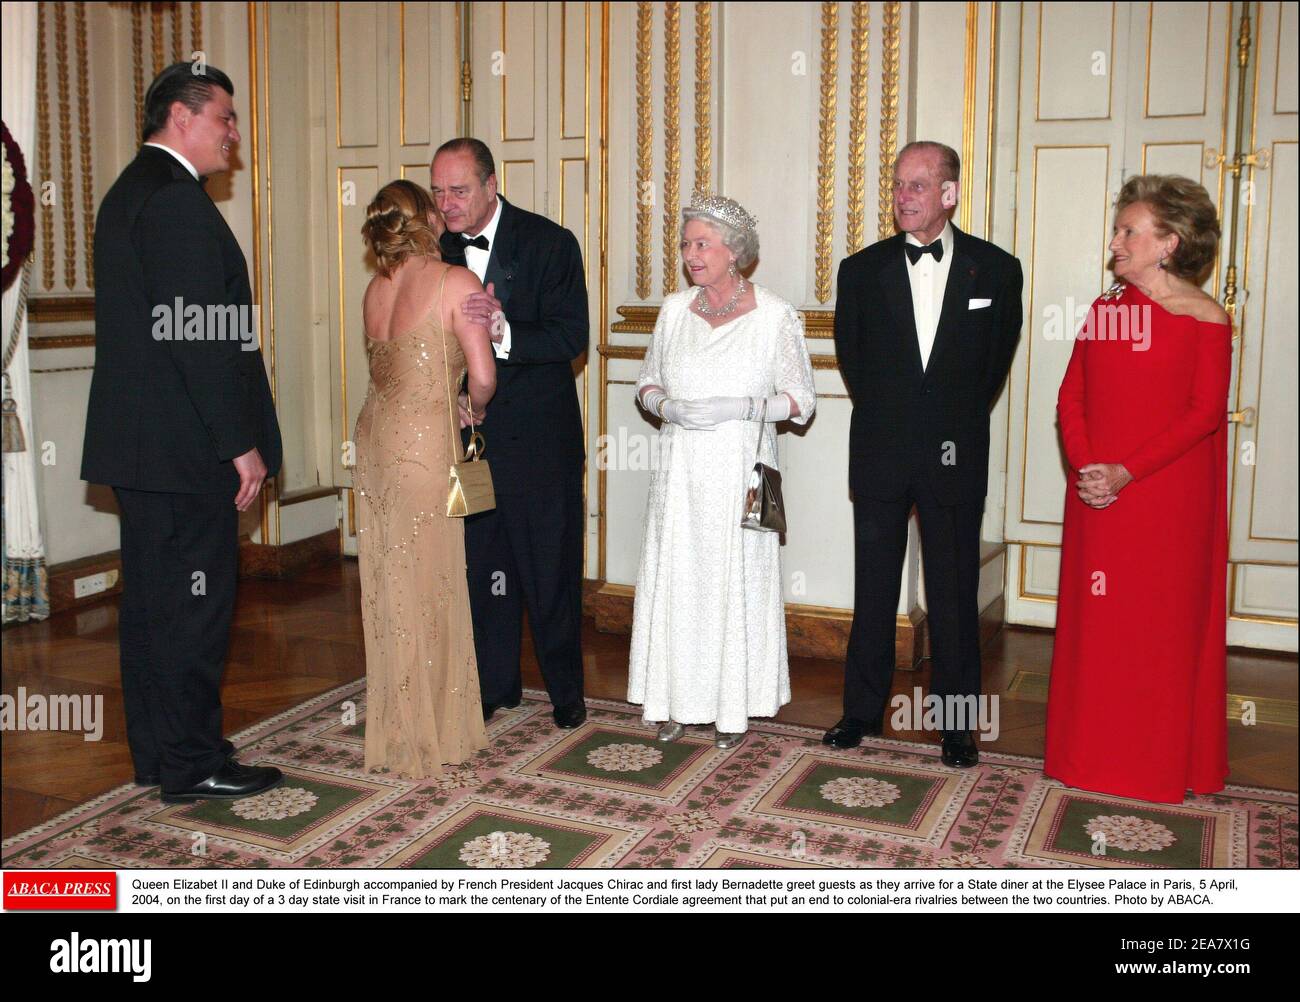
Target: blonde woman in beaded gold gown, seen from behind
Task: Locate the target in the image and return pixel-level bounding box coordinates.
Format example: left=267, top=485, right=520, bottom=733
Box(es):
left=354, top=179, right=497, bottom=778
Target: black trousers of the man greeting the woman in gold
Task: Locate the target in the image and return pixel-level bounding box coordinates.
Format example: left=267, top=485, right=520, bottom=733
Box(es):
left=465, top=472, right=582, bottom=706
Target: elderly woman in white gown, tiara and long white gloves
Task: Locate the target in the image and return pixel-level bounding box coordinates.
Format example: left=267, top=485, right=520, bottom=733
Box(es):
left=628, top=195, right=816, bottom=749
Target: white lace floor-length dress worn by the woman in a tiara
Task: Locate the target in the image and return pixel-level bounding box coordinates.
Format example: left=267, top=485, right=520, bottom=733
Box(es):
left=628, top=285, right=816, bottom=733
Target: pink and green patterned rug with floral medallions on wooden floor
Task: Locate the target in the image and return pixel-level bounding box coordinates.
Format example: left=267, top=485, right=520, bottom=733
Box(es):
left=3, top=682, right=1297, bottom=869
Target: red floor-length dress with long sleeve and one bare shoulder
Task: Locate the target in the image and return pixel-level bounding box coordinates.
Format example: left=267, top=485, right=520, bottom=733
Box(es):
left=1044, top=285, right=1232, bottom=803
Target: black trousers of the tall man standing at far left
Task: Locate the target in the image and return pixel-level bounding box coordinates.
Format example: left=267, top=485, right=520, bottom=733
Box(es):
left=114, top=487, right=239, bottom=789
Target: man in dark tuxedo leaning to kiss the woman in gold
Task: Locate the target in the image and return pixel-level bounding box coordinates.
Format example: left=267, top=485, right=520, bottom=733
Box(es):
left=432, top=138, right=589, bottom=728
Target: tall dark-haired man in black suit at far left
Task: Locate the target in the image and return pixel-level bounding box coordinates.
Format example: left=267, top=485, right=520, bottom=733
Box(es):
left=82, top=62, right=283, bottom=803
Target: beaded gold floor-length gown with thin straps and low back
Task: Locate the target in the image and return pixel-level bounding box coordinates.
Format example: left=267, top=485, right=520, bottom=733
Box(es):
left=354, top=273, right=488, bottom=778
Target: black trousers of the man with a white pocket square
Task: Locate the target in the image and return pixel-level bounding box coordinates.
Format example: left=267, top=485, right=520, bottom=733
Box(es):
left=844, top=481, right=984, bottom=720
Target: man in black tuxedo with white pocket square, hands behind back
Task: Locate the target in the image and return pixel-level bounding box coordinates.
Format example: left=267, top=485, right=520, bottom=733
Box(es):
left=824, top=142, right=1023, bottom=767
